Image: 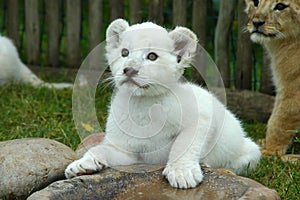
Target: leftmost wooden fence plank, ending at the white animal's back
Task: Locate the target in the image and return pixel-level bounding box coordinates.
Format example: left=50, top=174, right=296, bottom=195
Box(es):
left=7, top=0, right=20, bottom=49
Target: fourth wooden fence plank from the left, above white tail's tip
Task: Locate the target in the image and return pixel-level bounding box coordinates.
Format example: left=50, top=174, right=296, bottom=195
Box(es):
left=66, top=0, right=81, bottom=68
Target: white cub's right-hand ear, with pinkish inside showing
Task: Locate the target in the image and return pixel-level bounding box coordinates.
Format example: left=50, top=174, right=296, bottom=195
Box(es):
left=169, top=27, right=198, bottom=63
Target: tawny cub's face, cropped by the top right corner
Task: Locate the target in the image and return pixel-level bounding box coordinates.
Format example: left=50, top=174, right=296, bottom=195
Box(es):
left=245, top=0, right=300, bottom=43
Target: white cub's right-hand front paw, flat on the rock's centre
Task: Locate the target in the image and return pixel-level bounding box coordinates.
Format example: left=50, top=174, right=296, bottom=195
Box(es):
left=163, top=163, right=203, bottom=189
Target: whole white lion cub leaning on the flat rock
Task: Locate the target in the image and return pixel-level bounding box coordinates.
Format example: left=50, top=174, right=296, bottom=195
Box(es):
left=65, top=19, right=261, bottom=188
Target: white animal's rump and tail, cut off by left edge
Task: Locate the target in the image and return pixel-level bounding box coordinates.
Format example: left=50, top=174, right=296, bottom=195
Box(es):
left=0, top=36, right=73, bottom=89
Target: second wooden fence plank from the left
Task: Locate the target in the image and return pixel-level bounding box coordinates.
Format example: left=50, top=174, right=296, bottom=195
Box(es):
left=25, top=0, right=40, bottom=65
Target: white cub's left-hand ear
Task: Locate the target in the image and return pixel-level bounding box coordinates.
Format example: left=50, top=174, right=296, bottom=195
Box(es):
left=106, top=19, right=129, bottom=49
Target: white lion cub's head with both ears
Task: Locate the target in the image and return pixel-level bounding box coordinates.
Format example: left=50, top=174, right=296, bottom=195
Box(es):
left=106, top=19, right=197, bottom=96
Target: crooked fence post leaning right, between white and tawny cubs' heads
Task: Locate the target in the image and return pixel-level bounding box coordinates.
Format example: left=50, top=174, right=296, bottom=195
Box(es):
left=215, top=0, right=236, bottom=87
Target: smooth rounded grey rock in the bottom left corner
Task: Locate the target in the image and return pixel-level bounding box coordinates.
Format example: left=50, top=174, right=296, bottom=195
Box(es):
left=0, top=138, right=75, bottom=199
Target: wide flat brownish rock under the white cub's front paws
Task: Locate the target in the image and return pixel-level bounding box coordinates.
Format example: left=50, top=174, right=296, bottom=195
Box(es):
left=28, top=165, right=280, bottom=200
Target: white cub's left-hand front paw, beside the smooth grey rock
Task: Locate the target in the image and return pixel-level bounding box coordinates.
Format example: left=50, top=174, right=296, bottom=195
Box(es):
left=65, top=156, right=104, bottom=178
